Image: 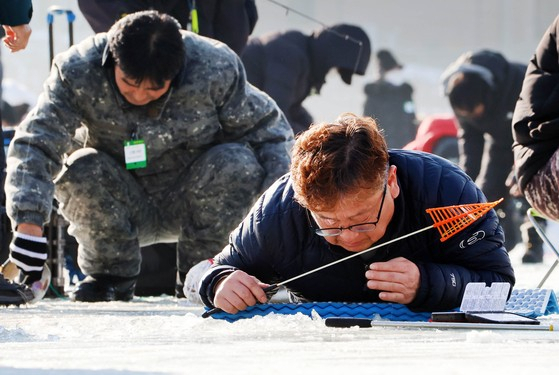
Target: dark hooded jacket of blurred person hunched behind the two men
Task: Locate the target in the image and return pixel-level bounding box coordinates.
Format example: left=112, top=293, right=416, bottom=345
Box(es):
left=241, top=24, right=371, bottom=134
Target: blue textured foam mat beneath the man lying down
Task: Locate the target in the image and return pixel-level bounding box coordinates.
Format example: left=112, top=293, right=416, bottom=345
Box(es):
left=211, top=289, right=559, bottom=322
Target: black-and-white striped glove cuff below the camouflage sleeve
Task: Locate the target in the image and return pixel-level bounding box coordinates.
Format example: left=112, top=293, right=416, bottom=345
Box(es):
left=10, top=232, right=47, bottom=285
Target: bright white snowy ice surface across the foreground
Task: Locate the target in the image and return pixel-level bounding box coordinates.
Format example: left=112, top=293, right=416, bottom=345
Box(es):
left=0, top=242, right=559, bottom=375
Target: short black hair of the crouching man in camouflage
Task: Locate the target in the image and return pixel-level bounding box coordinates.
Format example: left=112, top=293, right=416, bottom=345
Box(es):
left=109, top=10, right=186, bottom=86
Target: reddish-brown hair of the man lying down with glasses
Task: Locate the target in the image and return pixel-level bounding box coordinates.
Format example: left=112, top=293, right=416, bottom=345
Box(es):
left=291, top=113, right=388, bottom=210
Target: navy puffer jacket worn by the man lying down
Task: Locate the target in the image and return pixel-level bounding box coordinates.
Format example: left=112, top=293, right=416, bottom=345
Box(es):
left=200, top=150, right=515, bottom=311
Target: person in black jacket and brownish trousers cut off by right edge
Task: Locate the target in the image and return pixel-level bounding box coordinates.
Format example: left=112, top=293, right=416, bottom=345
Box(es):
left=512, top=17, right=559, bottom=225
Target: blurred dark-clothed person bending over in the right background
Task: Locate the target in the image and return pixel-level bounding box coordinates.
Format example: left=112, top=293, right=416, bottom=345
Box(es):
left=441, top=50, right=543, bottom=263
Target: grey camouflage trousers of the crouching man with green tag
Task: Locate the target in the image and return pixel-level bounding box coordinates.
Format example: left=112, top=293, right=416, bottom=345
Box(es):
left=55, top=143, right=265, bottom=277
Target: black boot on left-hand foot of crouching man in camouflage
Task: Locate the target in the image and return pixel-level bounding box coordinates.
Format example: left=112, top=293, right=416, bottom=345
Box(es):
left=70, top=275, right=137, bottom=302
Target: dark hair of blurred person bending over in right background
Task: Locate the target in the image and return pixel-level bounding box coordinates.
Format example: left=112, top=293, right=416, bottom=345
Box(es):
left=448, top=73, right=491, bottom=112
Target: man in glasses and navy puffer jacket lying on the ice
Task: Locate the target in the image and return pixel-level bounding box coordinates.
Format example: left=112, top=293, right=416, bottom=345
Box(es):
left=199, top=113, right=515, bottom=313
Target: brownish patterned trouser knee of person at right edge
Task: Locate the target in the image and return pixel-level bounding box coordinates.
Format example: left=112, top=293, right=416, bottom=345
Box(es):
left=524, top=149, right=559, bottom=221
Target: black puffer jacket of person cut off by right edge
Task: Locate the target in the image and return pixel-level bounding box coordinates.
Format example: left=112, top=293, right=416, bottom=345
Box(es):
left=512, top=17, right=559, bottom=191
